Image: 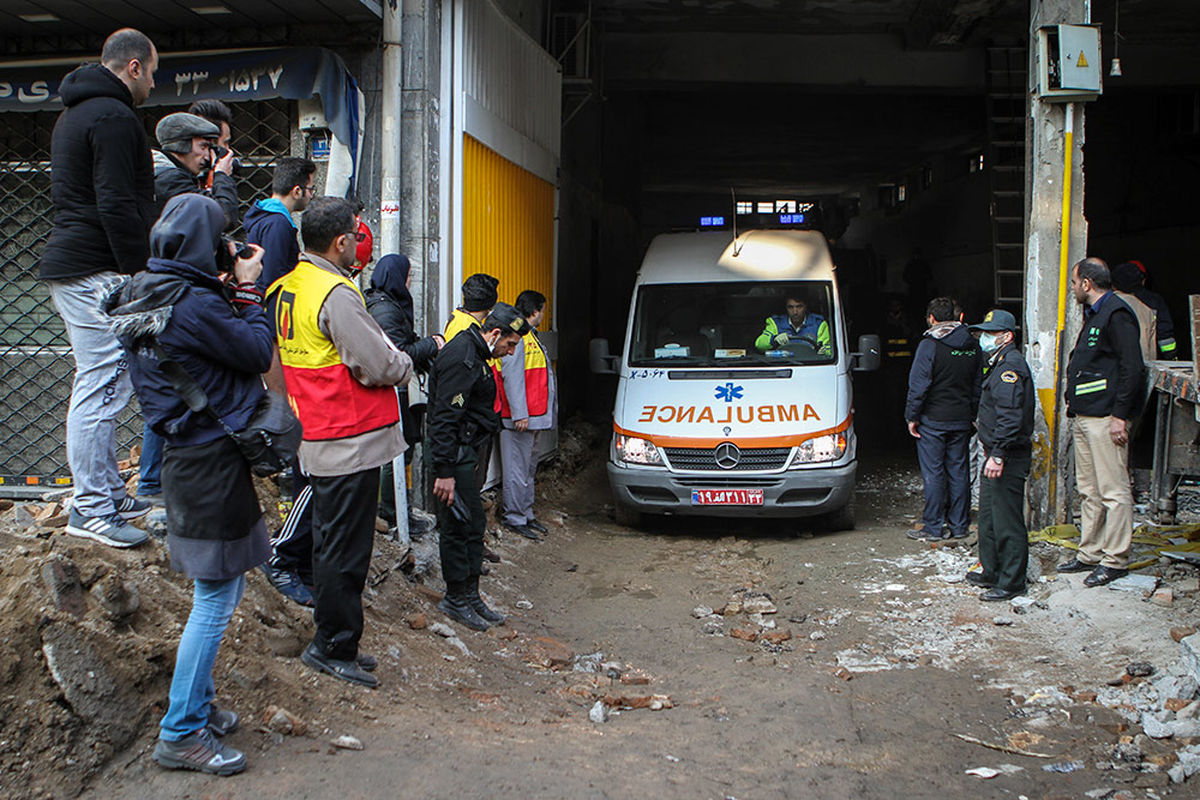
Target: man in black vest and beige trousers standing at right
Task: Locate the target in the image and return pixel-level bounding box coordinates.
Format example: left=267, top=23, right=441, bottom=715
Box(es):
left=1058, top=258, right=1145, bottom=587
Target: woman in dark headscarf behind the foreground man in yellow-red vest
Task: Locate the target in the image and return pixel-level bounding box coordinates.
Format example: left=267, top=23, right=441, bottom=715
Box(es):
left=364, top=254, right=445, bottom=524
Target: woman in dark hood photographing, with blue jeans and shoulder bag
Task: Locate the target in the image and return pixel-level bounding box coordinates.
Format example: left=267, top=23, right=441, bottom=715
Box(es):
left=104, top=194, right=274, bottom=775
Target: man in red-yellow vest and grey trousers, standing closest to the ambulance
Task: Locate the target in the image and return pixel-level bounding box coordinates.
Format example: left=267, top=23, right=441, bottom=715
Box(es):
left=499, top=289, right=558, bottom=541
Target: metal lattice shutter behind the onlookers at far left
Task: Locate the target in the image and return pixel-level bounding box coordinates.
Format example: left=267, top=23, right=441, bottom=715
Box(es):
left=0, top=100, right=295, bottom=485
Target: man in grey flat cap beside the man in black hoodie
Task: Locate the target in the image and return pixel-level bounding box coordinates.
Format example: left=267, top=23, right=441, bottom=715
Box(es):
left=154, top=112, right=239, bottom=230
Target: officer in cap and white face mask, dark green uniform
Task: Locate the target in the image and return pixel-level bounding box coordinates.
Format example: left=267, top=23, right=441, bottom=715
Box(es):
left=967, top=308, right=1033, bottom=601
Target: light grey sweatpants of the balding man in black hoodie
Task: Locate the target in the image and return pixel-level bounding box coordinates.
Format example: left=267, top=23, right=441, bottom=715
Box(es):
left=47, top=272, right=133, bottom=517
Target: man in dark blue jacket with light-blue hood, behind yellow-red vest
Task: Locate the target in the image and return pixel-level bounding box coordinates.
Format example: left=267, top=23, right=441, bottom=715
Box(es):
left=241, top=156, right=317, bottom=291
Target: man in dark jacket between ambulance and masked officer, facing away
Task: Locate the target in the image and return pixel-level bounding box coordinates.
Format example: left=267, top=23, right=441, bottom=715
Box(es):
left=905, top=297, right=982, bottom=541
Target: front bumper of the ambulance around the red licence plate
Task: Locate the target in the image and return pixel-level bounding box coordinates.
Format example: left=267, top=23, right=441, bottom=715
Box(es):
left=608, top=461, right=858, bottom=517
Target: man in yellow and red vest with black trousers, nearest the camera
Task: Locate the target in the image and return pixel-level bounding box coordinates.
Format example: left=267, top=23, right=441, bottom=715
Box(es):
left=268, top=197, right=413, bottom=687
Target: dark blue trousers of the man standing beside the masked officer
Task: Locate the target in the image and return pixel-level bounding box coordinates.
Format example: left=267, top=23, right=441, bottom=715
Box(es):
left=917, top=425, right=971, bottom=535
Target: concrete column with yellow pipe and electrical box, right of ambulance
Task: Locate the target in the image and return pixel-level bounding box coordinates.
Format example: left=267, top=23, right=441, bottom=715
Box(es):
left=1025, top=0, right=1091, bottom=529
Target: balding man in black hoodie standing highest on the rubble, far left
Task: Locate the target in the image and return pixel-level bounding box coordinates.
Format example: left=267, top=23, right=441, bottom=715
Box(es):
left=38, top=28, right=158, bottom=547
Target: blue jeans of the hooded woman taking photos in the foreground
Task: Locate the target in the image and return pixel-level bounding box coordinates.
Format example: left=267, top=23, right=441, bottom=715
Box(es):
left=158, top=575, right=246, bottom=741
